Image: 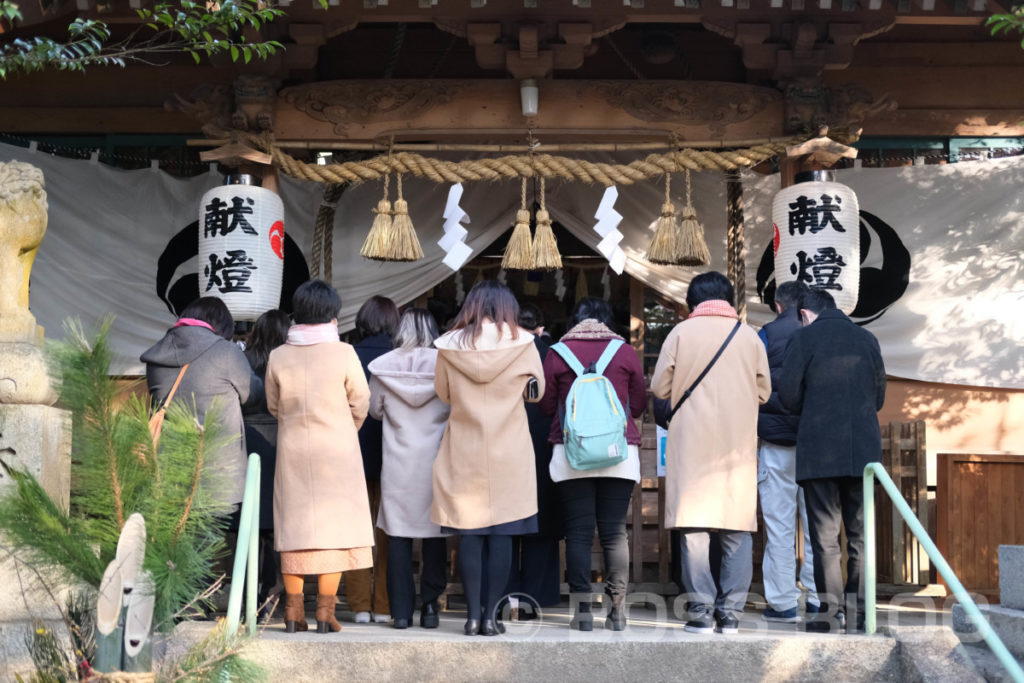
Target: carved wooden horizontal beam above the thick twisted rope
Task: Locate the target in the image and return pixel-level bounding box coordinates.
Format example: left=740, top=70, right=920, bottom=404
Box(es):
left=273, top=80, right=783, bottom=142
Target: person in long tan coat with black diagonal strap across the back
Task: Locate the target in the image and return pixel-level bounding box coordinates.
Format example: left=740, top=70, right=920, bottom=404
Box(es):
left=651, top=272, right=771, bottom=634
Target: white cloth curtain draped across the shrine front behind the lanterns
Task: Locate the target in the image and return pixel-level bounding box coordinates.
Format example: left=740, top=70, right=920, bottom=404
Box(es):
left=0, top=145, right=1024, bottom=388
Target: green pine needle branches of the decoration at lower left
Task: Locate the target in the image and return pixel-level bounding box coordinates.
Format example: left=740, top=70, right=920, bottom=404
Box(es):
left=0, top=319, right=238, bottom=630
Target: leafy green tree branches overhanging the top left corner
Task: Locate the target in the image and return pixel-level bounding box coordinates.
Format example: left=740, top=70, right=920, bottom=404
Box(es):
left=0, top=0, right=301, bottom=79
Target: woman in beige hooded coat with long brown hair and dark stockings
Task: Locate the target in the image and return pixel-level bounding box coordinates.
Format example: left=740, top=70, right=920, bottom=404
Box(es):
left=430, top=281, right=544, bottom=636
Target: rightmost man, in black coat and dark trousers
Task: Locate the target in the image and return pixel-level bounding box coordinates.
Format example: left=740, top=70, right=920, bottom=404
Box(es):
left=778, top=290, right=886, bottom=632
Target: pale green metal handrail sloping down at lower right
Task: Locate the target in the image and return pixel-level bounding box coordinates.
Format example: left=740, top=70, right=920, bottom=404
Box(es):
left=864, top=463, right=1024, bottom=683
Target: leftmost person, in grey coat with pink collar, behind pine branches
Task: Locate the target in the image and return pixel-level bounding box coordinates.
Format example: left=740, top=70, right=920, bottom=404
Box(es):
left=139, top=297, right=263, bottom=504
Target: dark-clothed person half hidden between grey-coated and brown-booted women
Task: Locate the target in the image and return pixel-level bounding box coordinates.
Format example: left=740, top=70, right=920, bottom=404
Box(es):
left=242, top=309, right=291, bottom=618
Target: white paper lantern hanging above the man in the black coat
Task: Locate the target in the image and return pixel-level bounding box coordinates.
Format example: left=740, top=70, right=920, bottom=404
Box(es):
left=771, top=181, right=860, bottom=314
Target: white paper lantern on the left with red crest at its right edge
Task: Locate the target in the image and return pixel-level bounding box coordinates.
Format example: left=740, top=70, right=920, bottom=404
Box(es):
left=199, top=185, right=285, bottom=321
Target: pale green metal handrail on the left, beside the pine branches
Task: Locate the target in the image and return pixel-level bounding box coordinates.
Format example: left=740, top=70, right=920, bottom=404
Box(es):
left=227, top=453, right=260, bottom=638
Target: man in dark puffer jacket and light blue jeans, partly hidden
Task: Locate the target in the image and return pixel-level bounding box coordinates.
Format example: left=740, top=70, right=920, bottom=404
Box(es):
left=758, top=282, right=818, bottom=624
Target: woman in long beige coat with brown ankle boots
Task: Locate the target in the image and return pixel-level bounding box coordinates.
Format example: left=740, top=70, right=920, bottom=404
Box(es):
left=266, top=280, right=374, bottom=633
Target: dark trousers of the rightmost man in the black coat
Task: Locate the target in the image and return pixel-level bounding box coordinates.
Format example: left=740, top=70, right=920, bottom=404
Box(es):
left=800, top=477, right=864, bottom=627
